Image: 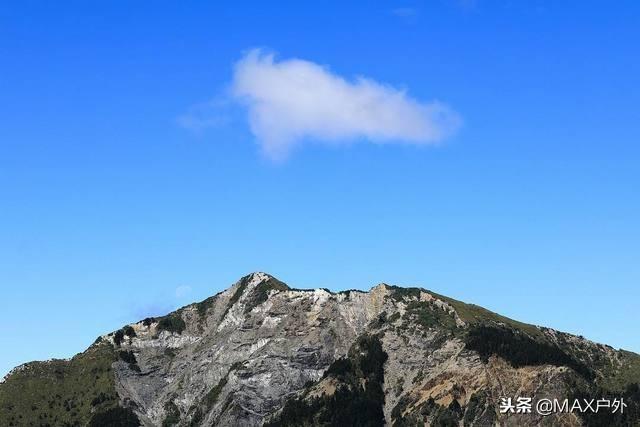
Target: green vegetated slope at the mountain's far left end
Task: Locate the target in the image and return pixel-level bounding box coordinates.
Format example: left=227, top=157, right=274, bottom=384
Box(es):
left=0, top=341, right=138, bottom=426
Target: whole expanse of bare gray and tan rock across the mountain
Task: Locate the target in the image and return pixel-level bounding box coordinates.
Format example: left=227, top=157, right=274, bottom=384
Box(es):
left=104, top=273, right=636, bottom=426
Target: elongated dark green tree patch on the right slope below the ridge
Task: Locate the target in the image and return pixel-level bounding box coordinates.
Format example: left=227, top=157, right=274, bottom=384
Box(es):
left=464, top=326, right=594, bottom=380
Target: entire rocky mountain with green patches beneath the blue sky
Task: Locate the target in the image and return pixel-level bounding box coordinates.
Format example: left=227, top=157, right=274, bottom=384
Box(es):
left=0, top=273, right=640, bottom=427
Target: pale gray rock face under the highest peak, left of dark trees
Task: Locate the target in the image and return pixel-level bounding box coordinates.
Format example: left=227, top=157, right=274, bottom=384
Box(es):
left=110, top=273, right=388, bottom=426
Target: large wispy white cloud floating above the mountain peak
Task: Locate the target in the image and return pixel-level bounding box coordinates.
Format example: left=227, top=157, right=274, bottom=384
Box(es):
left=231, top=50, right=460, bottom=159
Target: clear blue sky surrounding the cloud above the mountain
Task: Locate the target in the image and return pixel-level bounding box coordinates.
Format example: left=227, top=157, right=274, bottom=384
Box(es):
left=0, top=0, right=640, bottom=374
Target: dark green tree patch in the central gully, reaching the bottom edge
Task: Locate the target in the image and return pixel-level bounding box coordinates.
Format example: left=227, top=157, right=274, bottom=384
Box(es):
left=265, top=335, right=387, bottom=427
